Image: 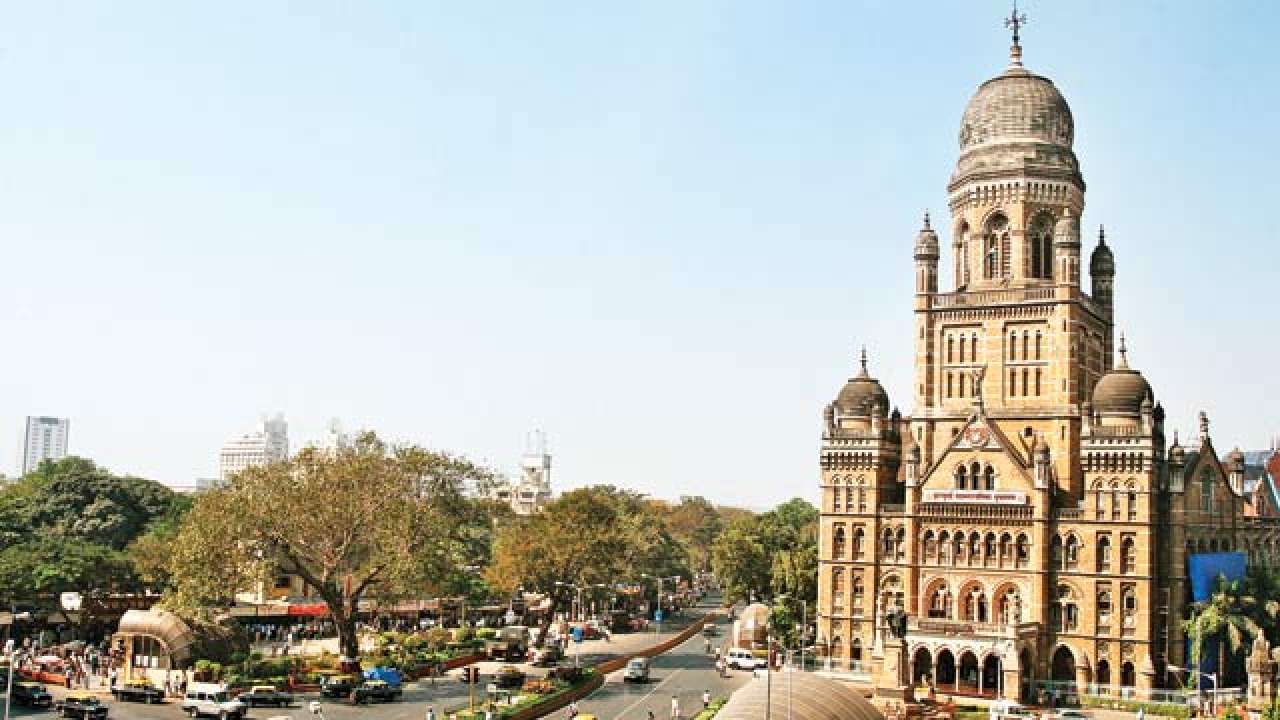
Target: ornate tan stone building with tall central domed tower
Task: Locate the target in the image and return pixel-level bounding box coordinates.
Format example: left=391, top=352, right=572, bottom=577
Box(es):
left=818, top=23, right=1280, bottom=698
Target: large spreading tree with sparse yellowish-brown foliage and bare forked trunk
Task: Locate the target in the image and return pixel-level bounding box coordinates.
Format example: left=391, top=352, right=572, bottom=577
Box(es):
left=169, top=433, right=486, bottom=659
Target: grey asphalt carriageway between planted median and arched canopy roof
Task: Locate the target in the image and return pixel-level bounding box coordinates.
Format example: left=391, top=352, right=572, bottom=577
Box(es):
left=570, top=607, right=751, bottom=720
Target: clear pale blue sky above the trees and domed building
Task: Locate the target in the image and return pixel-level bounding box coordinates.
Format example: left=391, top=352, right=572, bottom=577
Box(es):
left=0, top=1, right=1280, bottom=506
